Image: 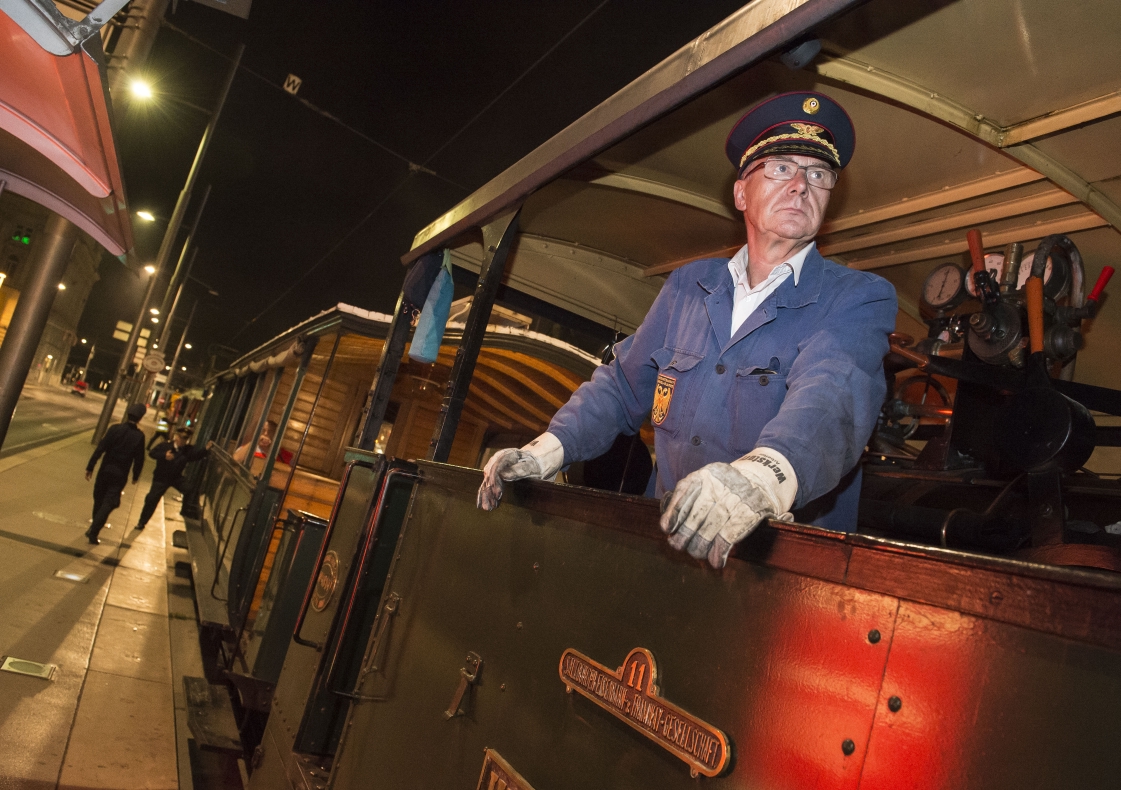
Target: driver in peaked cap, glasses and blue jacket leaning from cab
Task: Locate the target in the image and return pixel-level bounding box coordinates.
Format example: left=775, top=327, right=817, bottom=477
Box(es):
left=479, top=92, right=897, bottom=568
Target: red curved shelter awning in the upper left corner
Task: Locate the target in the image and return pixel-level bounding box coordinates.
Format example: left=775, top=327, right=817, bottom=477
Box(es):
left=0, top=11, right=132, bottom=255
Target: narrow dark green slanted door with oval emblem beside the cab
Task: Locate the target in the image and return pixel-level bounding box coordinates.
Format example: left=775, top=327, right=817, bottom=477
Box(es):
left=250, top=450, right=413, bottom=790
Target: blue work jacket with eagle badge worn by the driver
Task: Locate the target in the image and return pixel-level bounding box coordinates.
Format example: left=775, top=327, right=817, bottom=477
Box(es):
left=548, top=249, right=897, bottom=531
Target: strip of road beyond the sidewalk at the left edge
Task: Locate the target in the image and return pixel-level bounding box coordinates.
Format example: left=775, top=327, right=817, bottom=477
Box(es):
left=0, top=384, right=105, bottom=458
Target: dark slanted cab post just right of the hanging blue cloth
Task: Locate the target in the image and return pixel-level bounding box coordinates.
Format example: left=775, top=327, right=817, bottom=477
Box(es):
left=428, top=208, right=521, bottom=464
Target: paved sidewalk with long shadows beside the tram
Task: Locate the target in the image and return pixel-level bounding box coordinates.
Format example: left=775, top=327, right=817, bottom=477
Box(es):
left=0, top=431, right=203, bottom=790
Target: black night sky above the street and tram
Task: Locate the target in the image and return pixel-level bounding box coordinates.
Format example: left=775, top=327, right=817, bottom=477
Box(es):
left=78, top=0, right=742, bottom=374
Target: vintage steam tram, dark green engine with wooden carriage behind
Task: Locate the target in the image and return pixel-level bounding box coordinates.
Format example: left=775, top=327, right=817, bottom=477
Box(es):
left=179, top=0, right=1121, bottom=790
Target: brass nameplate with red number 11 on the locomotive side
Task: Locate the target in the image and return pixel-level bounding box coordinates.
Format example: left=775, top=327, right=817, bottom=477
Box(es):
left=561, top=648, right=729, bottom=777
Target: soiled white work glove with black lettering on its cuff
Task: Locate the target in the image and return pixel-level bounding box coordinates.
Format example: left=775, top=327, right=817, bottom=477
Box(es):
left=661, top=447, right=798, bottom=568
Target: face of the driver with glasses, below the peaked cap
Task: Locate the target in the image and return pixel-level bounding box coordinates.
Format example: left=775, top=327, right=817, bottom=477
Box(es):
left=732, top=154, right=830, bottom=242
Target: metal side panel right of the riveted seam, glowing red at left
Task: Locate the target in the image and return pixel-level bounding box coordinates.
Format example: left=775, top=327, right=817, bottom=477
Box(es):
left=860, top=602, right=1121, bottom=790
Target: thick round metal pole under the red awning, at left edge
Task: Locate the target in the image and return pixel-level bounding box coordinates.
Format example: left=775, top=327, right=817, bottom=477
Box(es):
left=0, top=214, right=77, bottom=447
